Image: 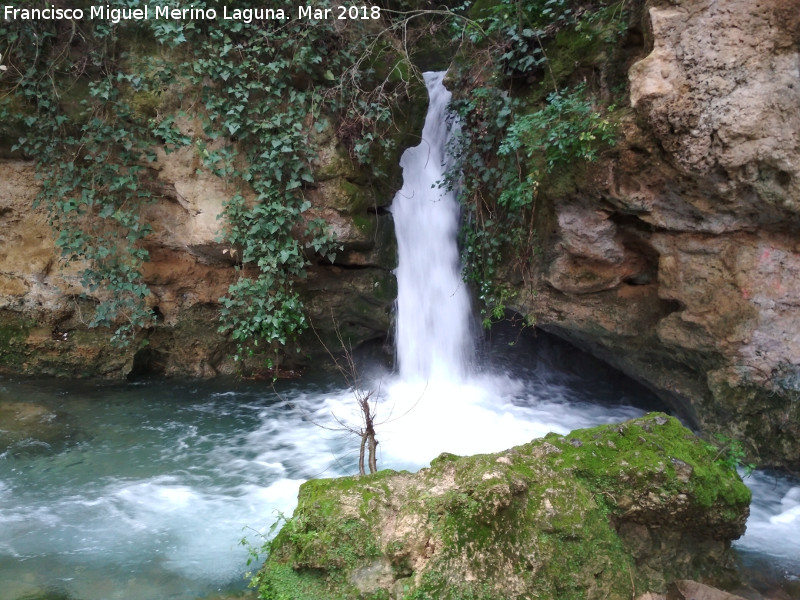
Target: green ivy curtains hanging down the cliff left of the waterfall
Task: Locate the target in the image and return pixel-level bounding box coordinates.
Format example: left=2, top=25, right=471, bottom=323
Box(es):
left=0, top=0, right=407, bottom=356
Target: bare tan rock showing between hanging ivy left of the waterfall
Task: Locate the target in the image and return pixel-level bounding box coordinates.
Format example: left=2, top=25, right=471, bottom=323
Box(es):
left=0, top=131, right=399, bottom=377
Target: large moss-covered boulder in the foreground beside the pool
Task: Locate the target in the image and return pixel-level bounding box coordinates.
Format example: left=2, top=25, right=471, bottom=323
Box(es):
left=256, top=413, right=750, bottom=600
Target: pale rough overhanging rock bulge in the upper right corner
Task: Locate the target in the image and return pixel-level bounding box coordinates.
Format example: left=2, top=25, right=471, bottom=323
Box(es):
left=630, top=0, right=800, bottom=199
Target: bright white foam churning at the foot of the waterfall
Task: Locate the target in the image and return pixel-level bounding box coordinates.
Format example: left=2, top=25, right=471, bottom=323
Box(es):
left=298, top=377, right=642, bottom=469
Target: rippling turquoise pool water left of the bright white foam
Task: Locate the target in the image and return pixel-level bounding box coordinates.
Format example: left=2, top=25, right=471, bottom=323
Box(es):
left=0, top=380, right=315, bottom=600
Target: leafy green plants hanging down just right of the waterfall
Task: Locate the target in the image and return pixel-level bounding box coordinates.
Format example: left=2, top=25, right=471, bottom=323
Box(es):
left=443, top=0, right=623, bottom=326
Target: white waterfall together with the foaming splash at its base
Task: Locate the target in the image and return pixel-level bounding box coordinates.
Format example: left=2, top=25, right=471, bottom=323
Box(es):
left=378, top=72, right=638, bottom=469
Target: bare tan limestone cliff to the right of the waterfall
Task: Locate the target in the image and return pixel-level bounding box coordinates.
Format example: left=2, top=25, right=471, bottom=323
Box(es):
left=518, top=0, right=800, bottom=472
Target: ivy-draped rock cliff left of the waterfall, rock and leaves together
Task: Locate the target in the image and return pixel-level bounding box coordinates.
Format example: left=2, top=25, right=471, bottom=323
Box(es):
left=0, top=14, right=426, bottom=377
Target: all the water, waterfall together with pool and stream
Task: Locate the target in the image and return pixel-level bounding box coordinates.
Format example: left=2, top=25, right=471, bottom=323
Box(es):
left=0, top=73, right=800, bottom=600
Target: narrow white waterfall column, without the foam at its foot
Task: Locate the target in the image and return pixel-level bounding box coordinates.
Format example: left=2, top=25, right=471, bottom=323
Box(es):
left=391, top=72, right=472, bottom=381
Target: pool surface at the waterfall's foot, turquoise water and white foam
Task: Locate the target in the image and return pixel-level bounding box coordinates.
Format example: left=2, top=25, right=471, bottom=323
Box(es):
left=0, top=340, right=800, bottom=600
